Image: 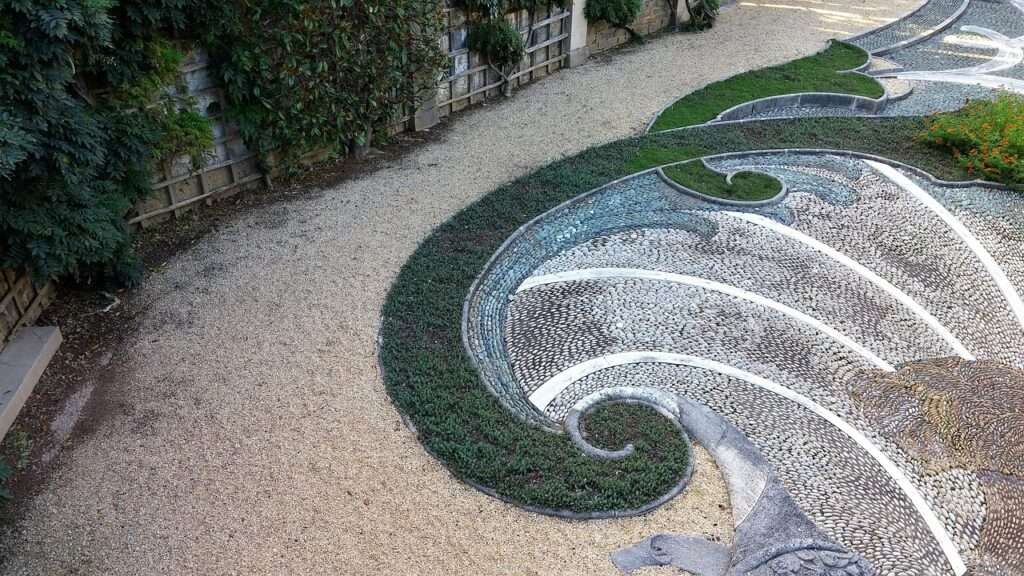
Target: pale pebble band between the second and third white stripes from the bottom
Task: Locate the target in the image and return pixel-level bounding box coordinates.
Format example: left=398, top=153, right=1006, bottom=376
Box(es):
left=532, top=222, right=954, bottom=365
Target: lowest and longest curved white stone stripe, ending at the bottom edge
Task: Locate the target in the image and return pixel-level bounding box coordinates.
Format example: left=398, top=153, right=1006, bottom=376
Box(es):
left=529, top=352, right=967, bottom=576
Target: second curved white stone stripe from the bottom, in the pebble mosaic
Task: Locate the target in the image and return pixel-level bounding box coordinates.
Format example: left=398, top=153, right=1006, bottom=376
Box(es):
left=517, top=268, right=896, bottom=372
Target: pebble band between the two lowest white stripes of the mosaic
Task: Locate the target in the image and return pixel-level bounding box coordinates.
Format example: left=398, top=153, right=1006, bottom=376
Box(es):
left=507, top=279, right=873, bottom=399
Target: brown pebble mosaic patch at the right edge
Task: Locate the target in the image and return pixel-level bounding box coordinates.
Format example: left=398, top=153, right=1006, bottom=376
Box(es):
left=851, top=359, right=1024, bottom=574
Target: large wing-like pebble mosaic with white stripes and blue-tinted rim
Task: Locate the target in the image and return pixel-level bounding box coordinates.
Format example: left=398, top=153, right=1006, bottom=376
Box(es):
left=465, top=153, right=1024, bottom=574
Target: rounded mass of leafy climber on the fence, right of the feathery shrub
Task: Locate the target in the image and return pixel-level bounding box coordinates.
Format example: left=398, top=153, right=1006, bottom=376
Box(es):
left=209, top=0, right=445, bottom=167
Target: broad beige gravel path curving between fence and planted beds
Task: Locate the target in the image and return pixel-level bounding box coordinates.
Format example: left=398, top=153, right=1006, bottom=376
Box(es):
left=3, top=0, right=918, bottom=576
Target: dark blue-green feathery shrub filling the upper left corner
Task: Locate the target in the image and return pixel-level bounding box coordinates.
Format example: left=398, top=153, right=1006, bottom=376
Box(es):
left=0, top=0, right=212, bottom=282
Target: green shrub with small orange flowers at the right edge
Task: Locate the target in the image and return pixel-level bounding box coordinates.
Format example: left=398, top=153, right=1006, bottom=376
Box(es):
left=919, top=93, right=1024, bottom=188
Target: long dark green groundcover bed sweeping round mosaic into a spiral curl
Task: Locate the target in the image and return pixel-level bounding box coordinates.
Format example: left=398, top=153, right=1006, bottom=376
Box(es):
left=380, top=113, right=965, bottom=512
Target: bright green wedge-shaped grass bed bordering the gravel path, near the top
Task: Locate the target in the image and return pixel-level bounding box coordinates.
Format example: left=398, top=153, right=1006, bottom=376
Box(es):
left=651, top=42, right=885, bottom=132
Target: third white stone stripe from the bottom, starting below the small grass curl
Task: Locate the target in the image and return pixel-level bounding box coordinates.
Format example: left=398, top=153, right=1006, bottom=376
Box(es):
left=723, top=208, right=975, bottom=360
